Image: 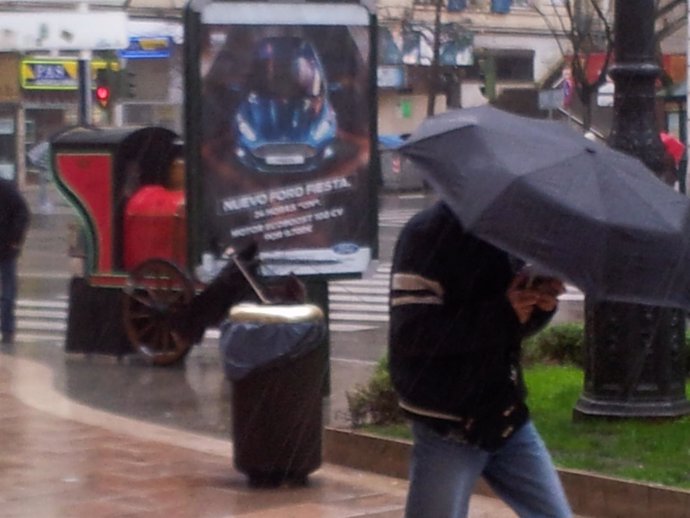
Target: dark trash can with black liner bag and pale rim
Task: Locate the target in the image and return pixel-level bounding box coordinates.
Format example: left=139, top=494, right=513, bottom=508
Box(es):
left=220, top=303, right=328, bottom=487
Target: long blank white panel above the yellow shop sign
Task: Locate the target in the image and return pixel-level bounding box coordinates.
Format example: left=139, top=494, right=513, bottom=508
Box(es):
left=0, top=11, right=129, bottom=52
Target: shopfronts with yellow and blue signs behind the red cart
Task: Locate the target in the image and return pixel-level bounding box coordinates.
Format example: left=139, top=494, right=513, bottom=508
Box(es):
left=0, top=23, right=184, bottom=186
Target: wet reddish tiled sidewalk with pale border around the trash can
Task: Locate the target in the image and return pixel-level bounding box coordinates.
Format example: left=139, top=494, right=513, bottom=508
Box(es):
left=0, top=353, right=514, bottom=518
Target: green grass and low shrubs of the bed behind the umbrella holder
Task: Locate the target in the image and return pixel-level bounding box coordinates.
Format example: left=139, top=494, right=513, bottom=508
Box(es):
left=348, top=327, right=690, bottom=490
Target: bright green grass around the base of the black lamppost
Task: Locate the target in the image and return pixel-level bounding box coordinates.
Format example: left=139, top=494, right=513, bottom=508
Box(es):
left=525, top=365, right=690, bottom=489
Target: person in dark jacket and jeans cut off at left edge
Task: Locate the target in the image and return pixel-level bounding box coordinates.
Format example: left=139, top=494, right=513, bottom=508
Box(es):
left=0, top=179, right=29, bottom=344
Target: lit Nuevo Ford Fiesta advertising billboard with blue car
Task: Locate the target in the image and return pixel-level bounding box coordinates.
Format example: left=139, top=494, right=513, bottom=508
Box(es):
left=187, top=2, right=377, bottom=275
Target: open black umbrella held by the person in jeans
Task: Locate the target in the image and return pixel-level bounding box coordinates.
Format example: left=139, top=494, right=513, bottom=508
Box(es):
left=400, top=106, right=690, bottom=307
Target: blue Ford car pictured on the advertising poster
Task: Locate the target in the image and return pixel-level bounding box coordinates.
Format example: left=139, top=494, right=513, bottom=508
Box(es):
left=233, top=36, right=337, bottom=173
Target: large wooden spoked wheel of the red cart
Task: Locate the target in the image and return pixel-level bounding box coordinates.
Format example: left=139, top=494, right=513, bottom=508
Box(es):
left=124, top=259, right=194, bottom=365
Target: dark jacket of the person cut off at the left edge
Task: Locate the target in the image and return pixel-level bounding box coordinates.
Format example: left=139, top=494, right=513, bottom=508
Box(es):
left=0, top=179, right=29, bottom=260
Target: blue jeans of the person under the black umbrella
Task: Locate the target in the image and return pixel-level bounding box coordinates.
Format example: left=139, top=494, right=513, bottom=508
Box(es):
left=405, top=421, right=572, bottom=518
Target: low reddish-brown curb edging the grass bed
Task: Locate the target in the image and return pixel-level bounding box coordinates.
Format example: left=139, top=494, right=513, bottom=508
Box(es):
left=324, top=428, right=690, bottom=518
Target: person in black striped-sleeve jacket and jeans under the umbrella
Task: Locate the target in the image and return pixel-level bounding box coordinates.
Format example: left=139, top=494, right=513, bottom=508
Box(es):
left=389, top=202, right=572, bottom=518
